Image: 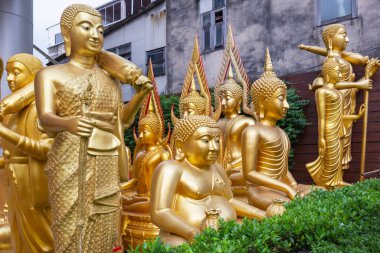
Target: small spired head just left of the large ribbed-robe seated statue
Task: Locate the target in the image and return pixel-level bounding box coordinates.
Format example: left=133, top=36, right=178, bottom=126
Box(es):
left=218, top=67, right=243, bottom=115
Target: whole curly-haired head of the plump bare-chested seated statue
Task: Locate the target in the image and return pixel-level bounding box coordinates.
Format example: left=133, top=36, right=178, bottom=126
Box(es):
left=173, top=115, right=221, bottom=168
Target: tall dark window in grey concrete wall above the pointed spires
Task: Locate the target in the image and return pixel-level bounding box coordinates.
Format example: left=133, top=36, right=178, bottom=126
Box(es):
left=200, top=0, right=226, bottom=51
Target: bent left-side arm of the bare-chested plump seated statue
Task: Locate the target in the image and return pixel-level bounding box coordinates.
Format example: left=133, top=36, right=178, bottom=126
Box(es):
left=151, top=161, right=199, bottom=240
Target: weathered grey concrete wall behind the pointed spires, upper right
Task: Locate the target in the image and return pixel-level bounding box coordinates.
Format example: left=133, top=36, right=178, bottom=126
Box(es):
left=167, top=0, right=380, bottom=93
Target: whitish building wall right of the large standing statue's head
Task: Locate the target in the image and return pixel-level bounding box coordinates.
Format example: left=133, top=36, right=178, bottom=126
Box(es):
left=103, top=3, right=168, bottom=101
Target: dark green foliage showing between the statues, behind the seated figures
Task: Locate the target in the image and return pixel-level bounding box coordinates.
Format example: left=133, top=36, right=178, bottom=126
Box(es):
left=124, top=84, right=309, bottom=169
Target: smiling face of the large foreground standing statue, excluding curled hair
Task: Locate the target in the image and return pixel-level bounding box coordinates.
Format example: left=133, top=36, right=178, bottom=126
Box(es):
left=62, top=12, right=104, bottom=56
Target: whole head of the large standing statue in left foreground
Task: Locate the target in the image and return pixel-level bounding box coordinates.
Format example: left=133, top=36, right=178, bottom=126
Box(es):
left=60, top=4, right=104, bottom=56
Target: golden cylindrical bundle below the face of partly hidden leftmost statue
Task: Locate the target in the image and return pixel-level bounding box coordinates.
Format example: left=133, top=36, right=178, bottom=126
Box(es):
left=0, top=83, right=34, bottom=117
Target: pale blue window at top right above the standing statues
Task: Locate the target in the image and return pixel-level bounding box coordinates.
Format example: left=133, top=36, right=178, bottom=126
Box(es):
left=316, top=0, right=357, bottom=26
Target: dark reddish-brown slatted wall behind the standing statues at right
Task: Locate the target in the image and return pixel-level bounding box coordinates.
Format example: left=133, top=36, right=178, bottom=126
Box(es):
left=282, top=67, right=380, bottom=183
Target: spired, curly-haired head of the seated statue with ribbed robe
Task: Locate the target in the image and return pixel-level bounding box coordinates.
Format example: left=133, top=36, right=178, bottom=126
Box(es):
left=251, top=48, right=289, bottom=121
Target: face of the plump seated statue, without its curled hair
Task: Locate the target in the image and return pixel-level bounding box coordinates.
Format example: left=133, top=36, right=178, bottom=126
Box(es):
left=181, top=127, right=220, bottom=168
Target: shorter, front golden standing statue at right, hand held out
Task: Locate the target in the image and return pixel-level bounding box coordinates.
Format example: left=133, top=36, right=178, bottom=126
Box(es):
left=306, top=53, right=374, bottom=188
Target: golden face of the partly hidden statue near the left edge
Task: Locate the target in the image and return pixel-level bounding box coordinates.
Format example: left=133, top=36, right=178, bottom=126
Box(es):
left=6, top=61, right=34, bottom=92
